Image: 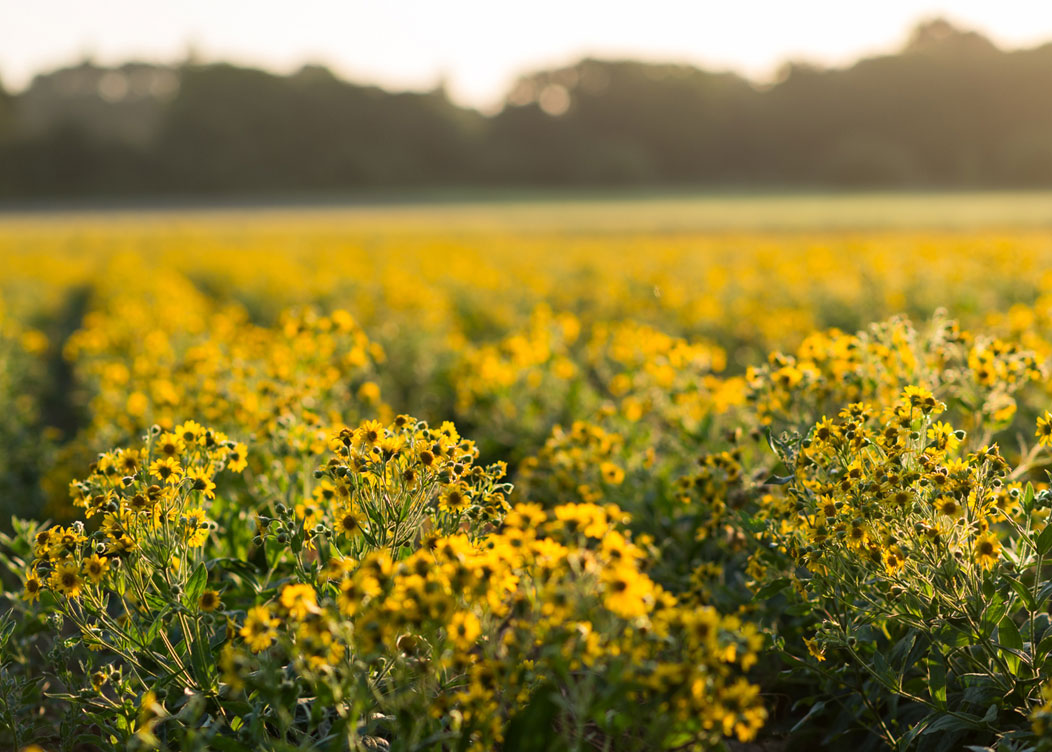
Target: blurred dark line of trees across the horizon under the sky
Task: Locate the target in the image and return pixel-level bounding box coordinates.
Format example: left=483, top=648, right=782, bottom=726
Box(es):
left=0, top=20, right=1052, bottom=199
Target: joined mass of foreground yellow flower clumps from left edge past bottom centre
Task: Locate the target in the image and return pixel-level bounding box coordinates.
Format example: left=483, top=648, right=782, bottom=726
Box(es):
left=12, top=415, right=766, bottom=749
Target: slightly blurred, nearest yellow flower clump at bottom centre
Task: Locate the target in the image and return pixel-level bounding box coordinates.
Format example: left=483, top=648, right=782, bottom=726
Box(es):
left=224, top=496, right=766, bottom=749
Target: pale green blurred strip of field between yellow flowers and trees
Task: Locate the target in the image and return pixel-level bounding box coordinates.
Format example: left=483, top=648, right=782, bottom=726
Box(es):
left=6, top=191, right=1052, bottom=232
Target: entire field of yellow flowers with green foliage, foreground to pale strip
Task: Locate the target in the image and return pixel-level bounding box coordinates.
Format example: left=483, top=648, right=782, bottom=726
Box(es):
left=6, top=212, right=1052, bottom=752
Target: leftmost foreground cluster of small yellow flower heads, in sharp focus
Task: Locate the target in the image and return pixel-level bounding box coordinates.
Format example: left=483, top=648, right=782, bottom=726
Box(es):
left=24, top=421, right=246, bottom=610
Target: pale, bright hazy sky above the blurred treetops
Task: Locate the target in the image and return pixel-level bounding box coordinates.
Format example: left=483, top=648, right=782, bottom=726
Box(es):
left=6, top=0, right=1052, bottom=107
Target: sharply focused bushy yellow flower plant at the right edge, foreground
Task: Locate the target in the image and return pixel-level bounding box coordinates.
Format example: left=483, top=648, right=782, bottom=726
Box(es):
left=754, top=393, right=1052, bottom=740
